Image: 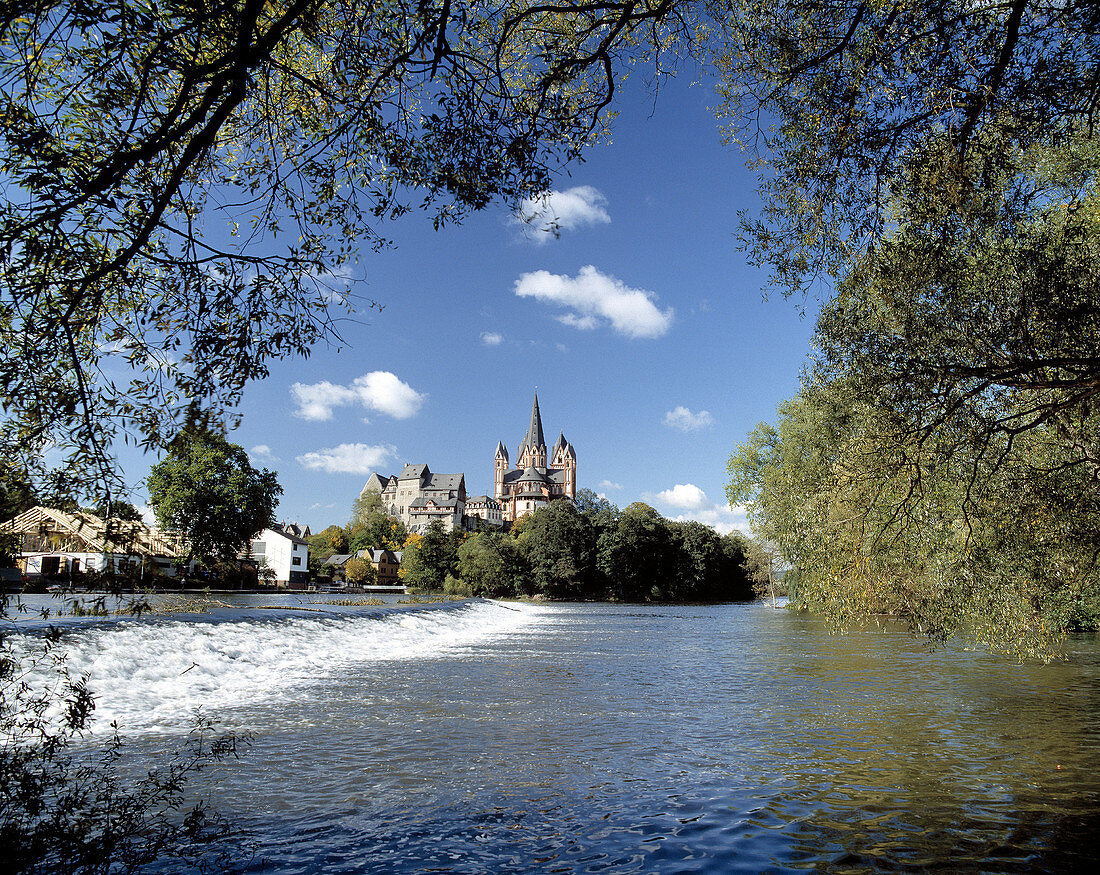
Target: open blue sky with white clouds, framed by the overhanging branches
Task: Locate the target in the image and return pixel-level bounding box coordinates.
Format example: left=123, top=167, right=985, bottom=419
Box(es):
left=127, top=73, right=813, bottom=532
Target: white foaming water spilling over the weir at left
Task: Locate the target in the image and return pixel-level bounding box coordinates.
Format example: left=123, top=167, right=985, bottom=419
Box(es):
left=15, top=602, right=537, bottom=734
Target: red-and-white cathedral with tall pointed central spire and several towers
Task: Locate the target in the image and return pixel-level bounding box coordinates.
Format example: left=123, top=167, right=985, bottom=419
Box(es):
left=496, top=393, right=576, bottom=522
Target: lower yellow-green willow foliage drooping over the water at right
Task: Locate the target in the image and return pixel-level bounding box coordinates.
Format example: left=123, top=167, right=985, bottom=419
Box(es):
left=727, top=384, right=1100, bottom=657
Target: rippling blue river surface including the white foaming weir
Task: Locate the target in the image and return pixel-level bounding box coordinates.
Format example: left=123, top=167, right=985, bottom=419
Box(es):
left=8, top=597, right=1100, bottom=873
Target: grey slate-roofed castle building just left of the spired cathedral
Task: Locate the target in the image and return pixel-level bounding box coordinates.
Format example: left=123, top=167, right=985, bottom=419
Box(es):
left=360, top=464, right=466, bottom=534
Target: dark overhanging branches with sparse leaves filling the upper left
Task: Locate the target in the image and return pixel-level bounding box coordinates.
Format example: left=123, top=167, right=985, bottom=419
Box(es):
left=0, top=0, right=692, bottom=504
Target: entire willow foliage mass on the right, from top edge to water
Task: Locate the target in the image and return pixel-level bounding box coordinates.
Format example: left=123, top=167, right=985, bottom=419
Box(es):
left=718, top=0, right=1100, bottom=650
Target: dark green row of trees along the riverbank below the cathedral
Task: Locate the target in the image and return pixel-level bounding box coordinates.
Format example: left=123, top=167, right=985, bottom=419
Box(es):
left=402, top=490, right=754, bottom=602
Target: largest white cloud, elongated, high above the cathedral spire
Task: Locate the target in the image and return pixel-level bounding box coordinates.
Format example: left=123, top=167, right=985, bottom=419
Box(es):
left=515, top=264, right=673, bottom=338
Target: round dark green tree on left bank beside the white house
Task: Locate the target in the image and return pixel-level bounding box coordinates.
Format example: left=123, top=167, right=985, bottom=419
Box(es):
left=147, top=429, right=283, bottom=561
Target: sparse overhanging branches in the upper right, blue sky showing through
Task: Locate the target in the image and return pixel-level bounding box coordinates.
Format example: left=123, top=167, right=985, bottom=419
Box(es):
left=711, top=0, right=1100, bottom=301
